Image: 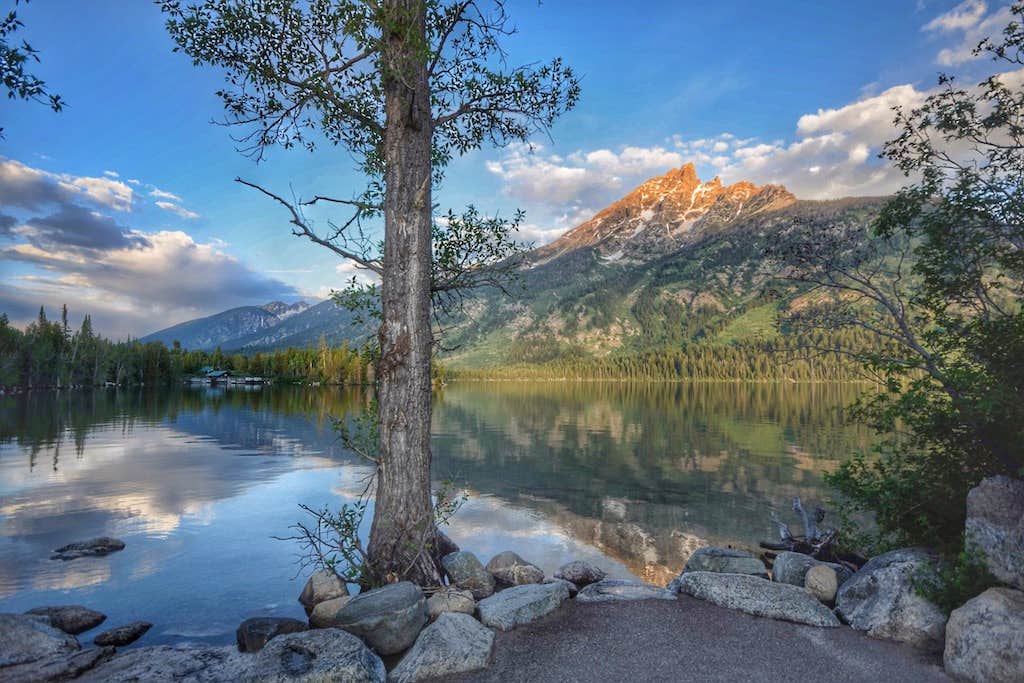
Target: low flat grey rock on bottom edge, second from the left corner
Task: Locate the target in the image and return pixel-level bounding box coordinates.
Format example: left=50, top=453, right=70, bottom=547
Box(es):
left=75, top=645, right=256, bottom=683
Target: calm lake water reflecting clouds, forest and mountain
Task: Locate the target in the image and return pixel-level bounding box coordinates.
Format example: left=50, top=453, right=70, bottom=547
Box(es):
left=0, top=383, right=869, bottom=644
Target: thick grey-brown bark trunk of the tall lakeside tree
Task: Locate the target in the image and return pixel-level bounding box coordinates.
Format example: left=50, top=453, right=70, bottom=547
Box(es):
left=368, top=0, right=440, bottom=586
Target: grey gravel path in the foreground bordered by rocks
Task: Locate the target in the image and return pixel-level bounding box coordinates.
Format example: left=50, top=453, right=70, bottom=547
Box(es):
left=445, top=596, right=950, bottom=683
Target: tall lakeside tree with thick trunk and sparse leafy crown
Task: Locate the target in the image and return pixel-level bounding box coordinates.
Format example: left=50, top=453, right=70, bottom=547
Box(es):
left=161, top=0, right=580, bottom=585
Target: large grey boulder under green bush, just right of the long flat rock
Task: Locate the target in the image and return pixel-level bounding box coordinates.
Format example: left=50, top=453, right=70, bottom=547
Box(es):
left=836, top=548, right=946, bottom=652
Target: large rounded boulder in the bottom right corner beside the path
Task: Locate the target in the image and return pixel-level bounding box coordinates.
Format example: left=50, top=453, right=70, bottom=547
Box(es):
left=943, top=588, right=1024, bottom=683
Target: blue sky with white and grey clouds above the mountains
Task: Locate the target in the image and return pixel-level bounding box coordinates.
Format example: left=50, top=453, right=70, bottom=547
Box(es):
left=0, top=0, right=1009, bottom=339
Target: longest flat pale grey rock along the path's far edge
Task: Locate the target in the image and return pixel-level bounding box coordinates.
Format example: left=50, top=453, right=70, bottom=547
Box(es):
left=679, top=571, right=839, bottom=627
